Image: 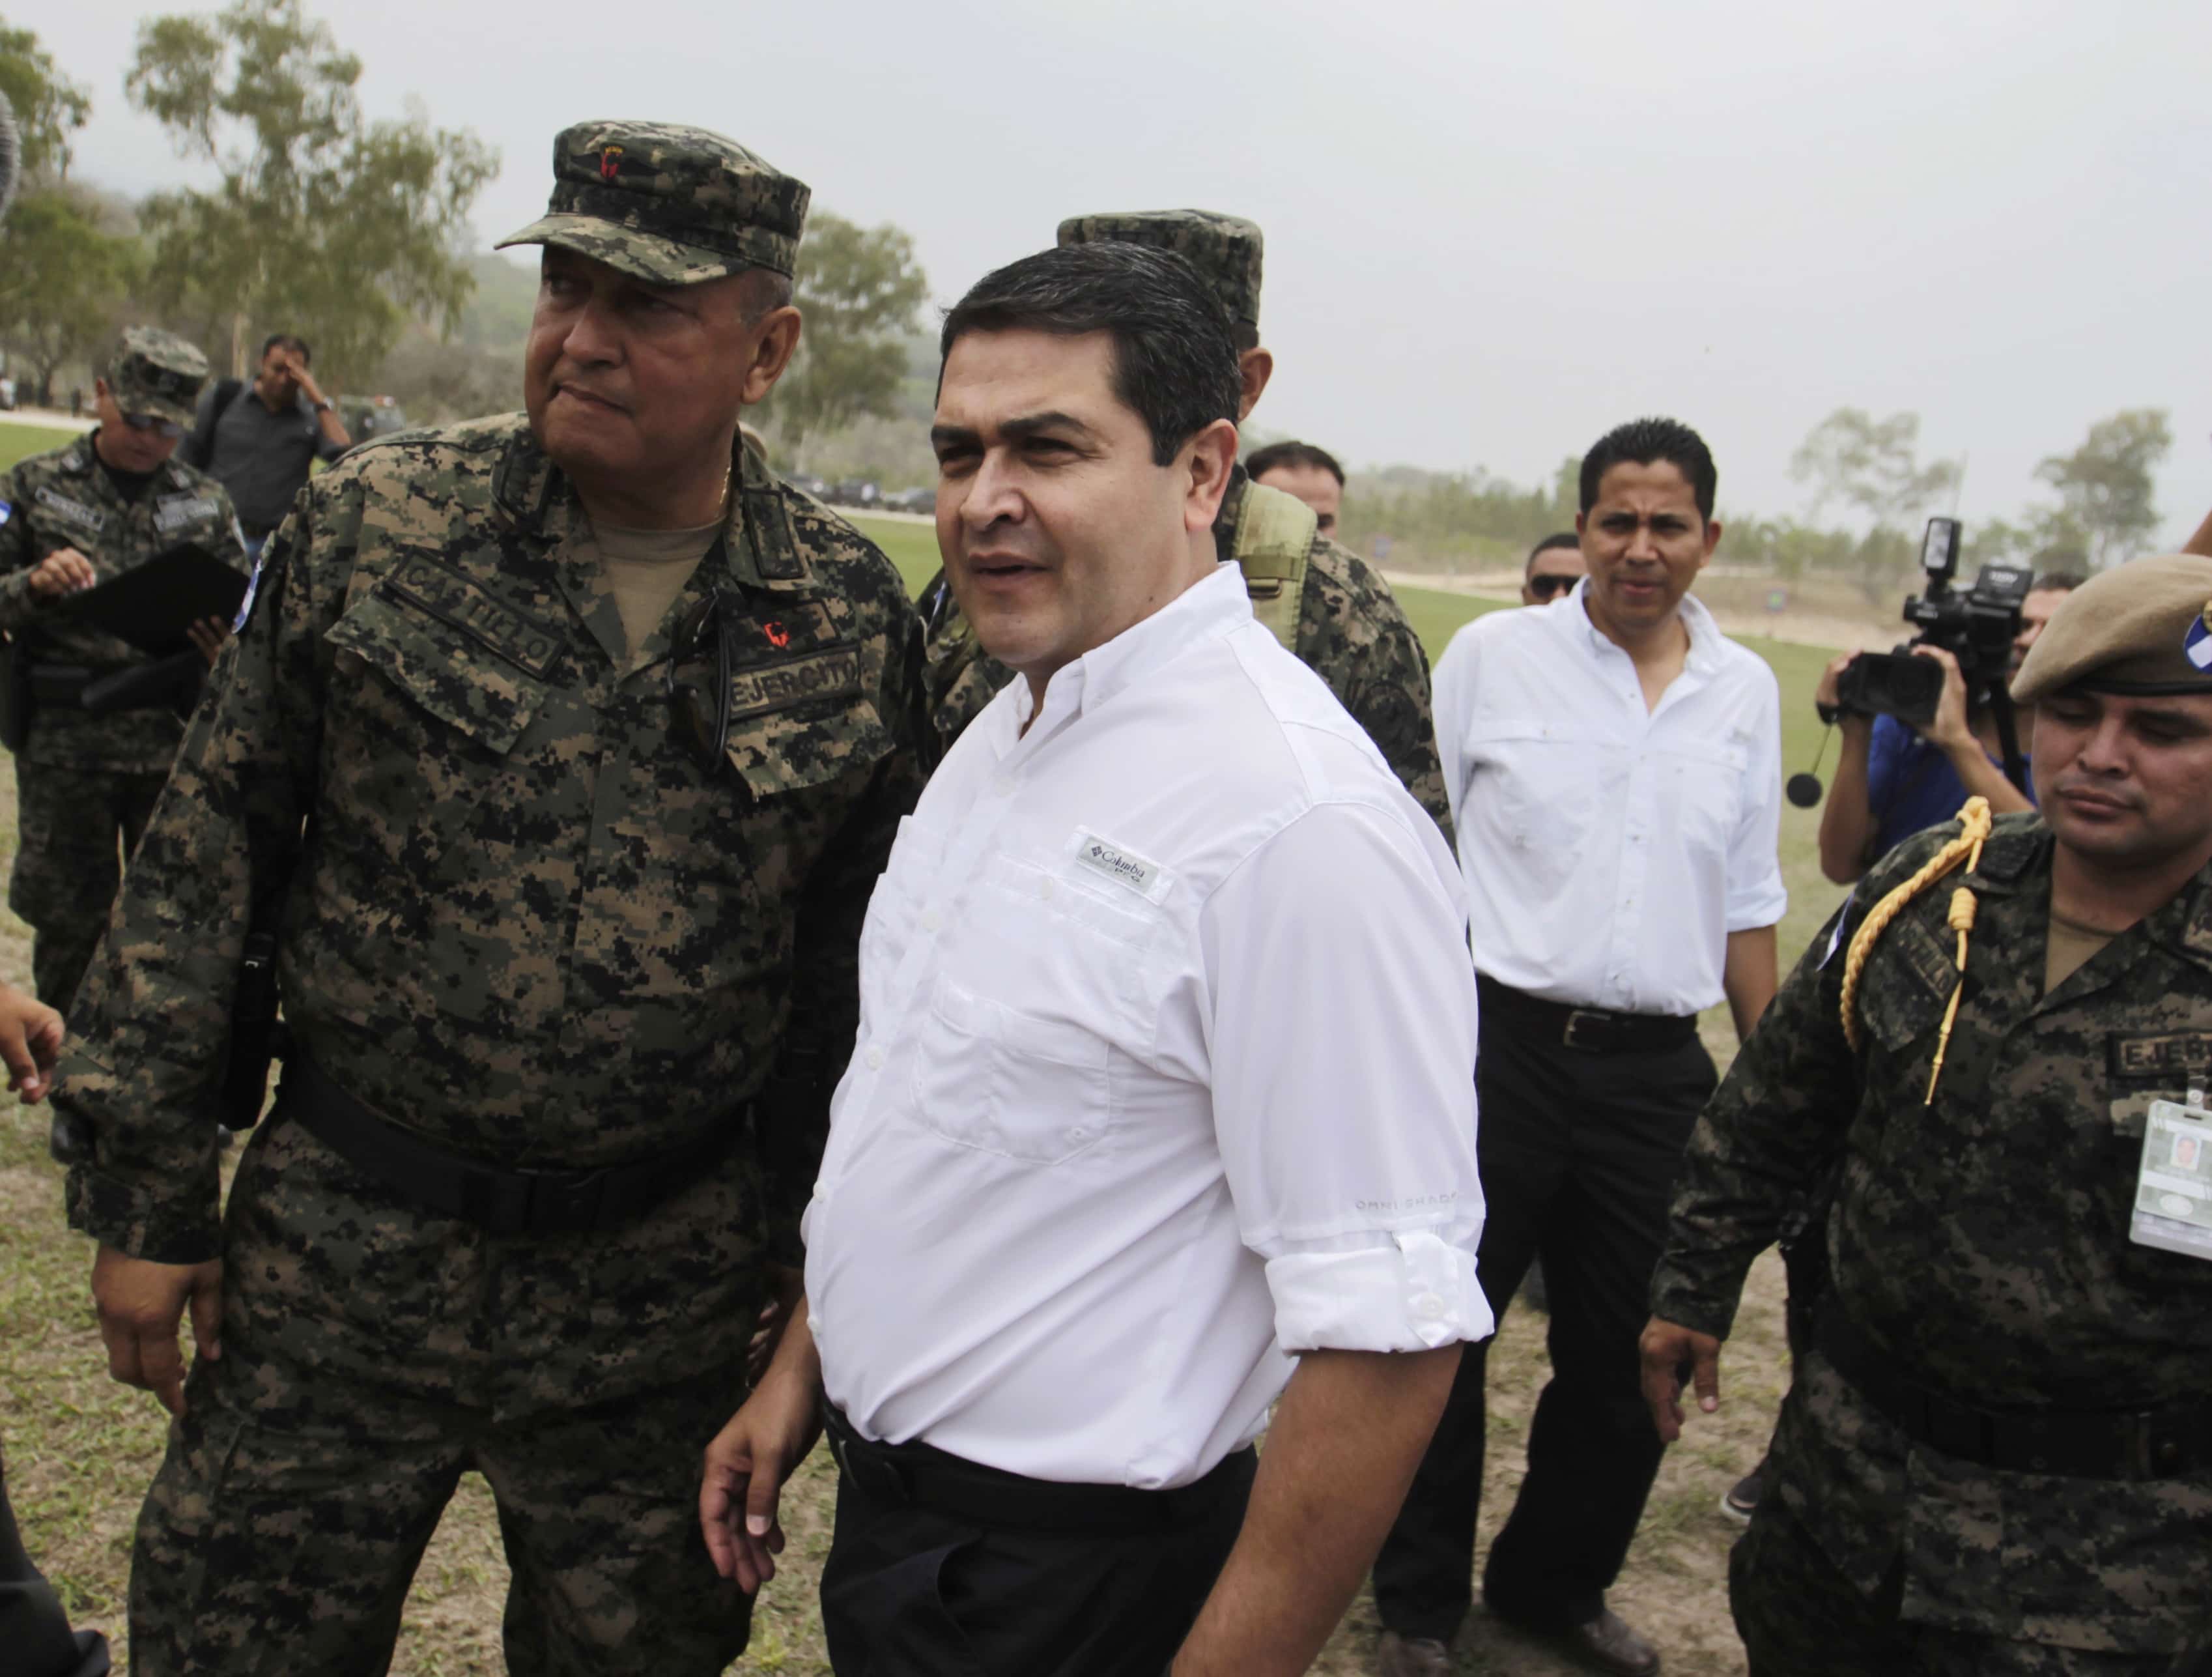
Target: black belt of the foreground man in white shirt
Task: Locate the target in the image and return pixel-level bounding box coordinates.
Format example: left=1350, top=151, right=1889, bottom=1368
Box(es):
left=823, top=1403, right=1258, bottom=1538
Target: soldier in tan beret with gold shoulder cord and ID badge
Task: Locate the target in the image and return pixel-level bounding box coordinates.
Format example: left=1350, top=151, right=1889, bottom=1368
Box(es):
left=1643, top=555, right=2212, bottom=1677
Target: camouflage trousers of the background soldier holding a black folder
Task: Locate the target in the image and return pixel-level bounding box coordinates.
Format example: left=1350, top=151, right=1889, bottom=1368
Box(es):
left=7, top=756, right=168, bottom=1013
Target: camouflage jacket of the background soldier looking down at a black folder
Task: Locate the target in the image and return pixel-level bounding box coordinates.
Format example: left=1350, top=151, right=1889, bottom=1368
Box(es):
left=0, top=434, right=246, bottom=775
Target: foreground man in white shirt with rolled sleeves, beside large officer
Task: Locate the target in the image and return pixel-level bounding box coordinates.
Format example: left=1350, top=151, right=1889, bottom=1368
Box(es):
left=702, top=244, right=1491, bottom=1677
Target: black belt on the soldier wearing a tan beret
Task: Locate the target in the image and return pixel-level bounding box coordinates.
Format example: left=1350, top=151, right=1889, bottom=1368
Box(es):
left=1816, top=1298, right=2212, bottom=1480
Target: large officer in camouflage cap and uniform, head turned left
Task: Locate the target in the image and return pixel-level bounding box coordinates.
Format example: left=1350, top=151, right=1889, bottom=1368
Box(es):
left=57, top=122, right=927, bottom=1677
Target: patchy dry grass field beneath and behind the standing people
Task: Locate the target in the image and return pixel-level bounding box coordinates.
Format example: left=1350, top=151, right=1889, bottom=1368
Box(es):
left=0, top=480, right=1836, bottom=1677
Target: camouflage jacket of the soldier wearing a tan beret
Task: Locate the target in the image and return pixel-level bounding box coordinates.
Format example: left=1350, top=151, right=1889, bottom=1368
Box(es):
left=1652, top=814, right=2212, bottom=1653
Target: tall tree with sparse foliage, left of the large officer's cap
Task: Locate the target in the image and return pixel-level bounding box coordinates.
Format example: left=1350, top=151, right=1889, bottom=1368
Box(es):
left=124, top=0, right=498, bottom=379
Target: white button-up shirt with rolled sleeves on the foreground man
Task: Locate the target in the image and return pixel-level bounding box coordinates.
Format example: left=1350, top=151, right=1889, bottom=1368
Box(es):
left=805, top=566, right=1491, bottom=1487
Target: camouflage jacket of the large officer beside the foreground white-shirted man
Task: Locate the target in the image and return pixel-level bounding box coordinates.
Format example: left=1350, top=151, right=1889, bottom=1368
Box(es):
left=57, top=416, right=927, bottom=1263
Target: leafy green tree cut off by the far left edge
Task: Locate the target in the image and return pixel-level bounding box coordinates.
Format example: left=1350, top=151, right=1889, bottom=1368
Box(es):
left=0, top=24, right=135, bottom=405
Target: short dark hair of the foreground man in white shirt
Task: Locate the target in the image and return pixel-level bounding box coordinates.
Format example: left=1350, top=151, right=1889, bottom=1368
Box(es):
left=938, top=239, right=1243, bottom=465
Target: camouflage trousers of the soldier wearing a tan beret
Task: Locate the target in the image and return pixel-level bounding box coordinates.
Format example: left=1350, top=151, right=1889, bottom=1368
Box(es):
left=1727, top=1496, right=2174, bottom=1677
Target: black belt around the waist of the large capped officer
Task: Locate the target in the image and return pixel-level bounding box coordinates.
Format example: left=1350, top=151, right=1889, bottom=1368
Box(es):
left=277, top=1044, right=745, bottom=1235
